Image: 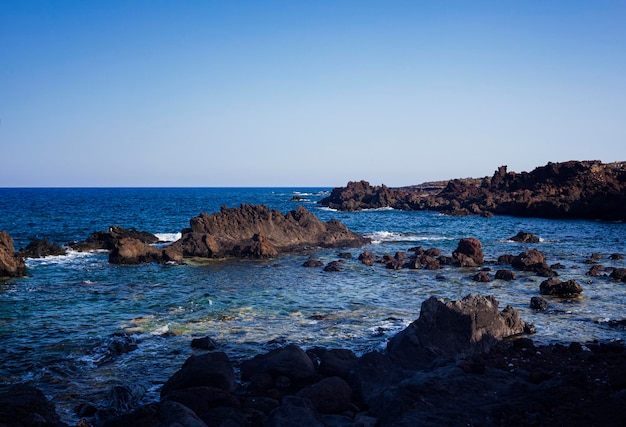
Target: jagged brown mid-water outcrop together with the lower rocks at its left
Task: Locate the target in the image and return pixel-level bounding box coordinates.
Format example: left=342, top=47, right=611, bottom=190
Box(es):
left=81, top=204, right=370, bottom=264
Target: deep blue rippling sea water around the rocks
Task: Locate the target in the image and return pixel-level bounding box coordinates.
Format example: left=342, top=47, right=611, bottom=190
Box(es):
left=0, top=188, right=626, bottom=422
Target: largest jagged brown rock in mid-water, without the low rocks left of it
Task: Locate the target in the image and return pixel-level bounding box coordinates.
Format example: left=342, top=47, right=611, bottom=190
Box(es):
left=172, top=204, right=369, bottom=258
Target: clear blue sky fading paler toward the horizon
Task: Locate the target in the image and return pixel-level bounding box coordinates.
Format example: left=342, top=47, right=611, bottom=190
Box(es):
left=0, top=0, right=626, bottom=187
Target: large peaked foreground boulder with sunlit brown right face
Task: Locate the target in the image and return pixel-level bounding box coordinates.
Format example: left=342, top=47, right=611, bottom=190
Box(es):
left=387, top=294, right=533, bottom=368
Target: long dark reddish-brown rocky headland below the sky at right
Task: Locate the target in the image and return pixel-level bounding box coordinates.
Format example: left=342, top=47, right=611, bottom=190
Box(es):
left=320, top=161, right=626, bottom=221
